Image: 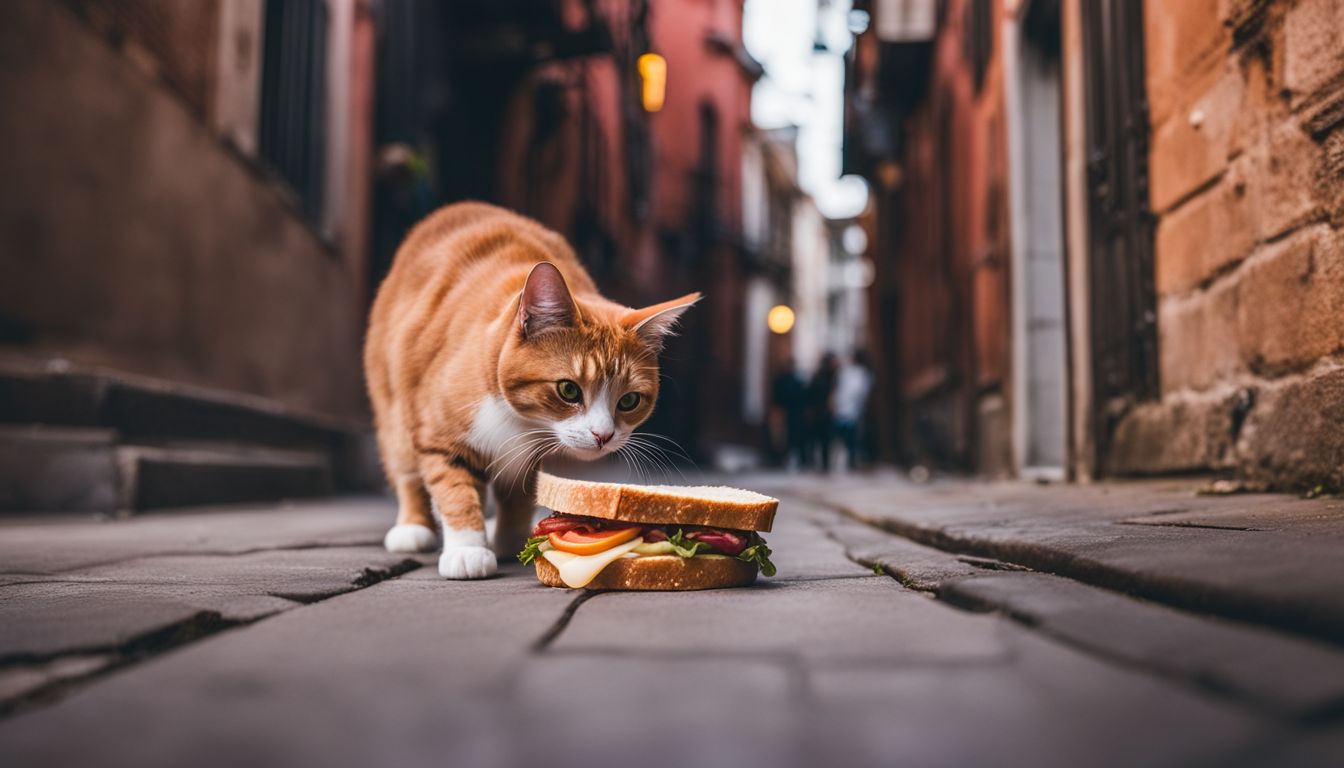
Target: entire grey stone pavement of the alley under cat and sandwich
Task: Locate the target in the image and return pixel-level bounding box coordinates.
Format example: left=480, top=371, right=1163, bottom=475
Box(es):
left=0, top=475, right=1344, bottom=768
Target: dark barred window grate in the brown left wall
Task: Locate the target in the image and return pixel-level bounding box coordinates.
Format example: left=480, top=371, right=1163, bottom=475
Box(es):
left=261, top=0, right=328, bottom=222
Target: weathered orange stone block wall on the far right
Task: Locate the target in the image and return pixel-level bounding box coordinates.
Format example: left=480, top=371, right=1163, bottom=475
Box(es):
left=1110, top=0, right=1344, bottom=487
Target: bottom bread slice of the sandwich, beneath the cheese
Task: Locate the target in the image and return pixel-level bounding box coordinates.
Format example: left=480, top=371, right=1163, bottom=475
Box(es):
left=535, top=554, right=757, bottom=592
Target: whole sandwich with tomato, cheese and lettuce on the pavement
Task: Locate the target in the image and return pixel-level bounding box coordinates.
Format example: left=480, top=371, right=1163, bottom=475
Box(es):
left=517, top=472, right=780, bottom=590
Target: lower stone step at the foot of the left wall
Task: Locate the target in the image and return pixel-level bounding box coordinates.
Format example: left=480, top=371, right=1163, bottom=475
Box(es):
left=0, top=426, right=335, bottom=514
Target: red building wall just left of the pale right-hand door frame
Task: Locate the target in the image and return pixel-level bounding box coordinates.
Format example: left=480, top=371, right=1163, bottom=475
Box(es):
left=857, top=0, right=1008, bottom=472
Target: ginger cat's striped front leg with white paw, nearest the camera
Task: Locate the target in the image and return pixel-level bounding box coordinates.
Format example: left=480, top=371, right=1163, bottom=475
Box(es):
left=421, top=453, right=499, bottom=578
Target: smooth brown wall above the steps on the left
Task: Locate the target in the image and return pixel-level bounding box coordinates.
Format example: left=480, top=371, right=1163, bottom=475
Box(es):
left=0, top=0, right=366, bottom=417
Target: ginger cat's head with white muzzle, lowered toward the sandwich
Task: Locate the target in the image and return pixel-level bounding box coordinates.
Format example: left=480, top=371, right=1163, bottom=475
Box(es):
left=499, top=262, right=700, bottom=460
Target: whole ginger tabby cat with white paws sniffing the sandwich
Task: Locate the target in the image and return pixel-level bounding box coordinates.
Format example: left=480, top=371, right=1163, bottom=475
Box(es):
left=364, top=203, right=700, bottom=578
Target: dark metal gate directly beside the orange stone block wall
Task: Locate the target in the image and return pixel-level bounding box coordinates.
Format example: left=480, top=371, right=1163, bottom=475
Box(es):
left=1079, top=0, right=1157, bottom=467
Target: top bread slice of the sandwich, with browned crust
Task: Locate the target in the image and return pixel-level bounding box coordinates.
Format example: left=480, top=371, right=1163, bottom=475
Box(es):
left=536, top=472, right=780, bottom=531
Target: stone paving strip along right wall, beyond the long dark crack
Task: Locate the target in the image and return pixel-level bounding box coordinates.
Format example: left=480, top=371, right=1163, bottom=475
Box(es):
left=767, top=475, right=1344, bottom=644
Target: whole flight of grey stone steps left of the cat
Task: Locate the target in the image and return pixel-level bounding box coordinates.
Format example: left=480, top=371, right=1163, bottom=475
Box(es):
left=0, top=366, right=382, bottom=512
